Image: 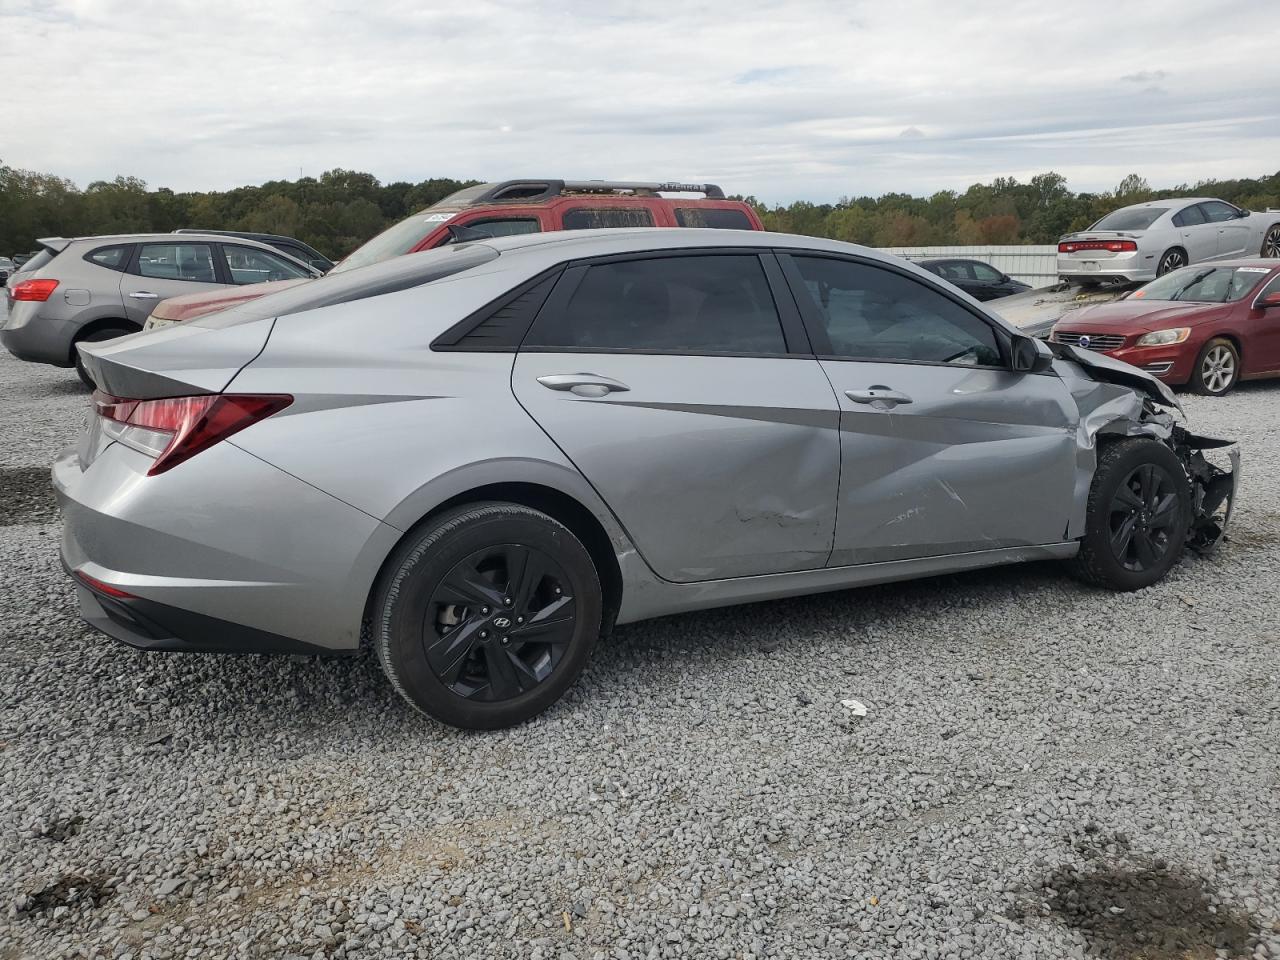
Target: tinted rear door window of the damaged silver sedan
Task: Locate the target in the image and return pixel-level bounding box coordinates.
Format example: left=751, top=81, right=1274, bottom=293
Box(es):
left=527, top=255, right=786, bottom=353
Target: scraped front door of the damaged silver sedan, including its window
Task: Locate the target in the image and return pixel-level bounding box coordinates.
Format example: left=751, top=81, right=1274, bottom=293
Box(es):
left=780, top=252, right=1076, bottom=566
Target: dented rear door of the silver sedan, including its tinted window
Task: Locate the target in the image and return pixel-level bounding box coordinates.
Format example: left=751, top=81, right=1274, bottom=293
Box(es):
left=512, top=248, right=840, bottom=582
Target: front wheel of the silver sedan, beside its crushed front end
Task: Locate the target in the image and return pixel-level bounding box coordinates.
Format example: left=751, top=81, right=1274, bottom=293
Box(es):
left=1070, top=438, right=1192, bottom=590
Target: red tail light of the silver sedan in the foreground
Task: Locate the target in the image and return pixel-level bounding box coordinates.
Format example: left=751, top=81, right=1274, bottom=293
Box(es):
left=93, top=392, right=293, bottom=476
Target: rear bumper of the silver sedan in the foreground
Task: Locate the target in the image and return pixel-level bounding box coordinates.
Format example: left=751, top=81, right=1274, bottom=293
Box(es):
left=52, top=442, right=399, bottom=653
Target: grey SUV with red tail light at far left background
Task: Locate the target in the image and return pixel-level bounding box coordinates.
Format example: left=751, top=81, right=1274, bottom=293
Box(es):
left=0, top=233, right=320, bottom=387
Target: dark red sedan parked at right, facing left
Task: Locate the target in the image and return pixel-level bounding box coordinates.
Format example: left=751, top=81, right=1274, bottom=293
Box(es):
left=1050, top=260, right=1280, bottom=396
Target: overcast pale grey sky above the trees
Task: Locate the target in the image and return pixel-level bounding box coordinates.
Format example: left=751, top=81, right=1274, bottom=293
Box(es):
left=0, top=0, right=1280, bottom=202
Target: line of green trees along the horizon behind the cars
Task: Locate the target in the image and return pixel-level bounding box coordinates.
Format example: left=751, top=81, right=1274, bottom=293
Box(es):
left=0, top=163, right=1280, bottom=260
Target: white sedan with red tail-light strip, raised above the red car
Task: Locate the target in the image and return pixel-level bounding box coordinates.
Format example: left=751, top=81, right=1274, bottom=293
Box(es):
left=1057, top=197, right=1280, bottom=283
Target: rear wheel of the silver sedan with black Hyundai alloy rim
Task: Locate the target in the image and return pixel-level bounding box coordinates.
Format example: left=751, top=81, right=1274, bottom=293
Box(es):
left=371, top=503, right=603, bottom=730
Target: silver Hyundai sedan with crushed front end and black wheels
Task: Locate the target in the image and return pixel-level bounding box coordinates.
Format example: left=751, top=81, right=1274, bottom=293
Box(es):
left=54, top=229, right=1238, bottom=728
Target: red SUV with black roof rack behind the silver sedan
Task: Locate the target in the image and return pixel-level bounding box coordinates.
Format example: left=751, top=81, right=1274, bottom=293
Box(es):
left=146, top=180, right=764, bottom=329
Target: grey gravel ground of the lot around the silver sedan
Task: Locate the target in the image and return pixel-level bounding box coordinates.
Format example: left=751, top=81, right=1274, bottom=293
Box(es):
left=0, top=356, right=1280, bottom=960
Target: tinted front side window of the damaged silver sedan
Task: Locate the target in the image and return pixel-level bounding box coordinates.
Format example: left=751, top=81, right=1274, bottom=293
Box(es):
left=795, top=257, right=1002, bottom=366
